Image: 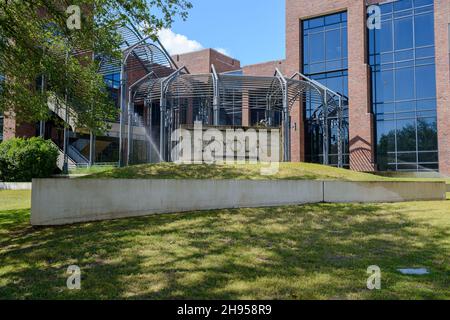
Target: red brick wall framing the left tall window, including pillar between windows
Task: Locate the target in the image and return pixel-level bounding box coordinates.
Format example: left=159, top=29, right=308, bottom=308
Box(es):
left=285, top=0, right=374, bottom=171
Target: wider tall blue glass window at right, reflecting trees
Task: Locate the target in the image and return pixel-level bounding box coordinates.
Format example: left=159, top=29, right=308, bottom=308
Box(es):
left=368, top=0, right=439, bottom=171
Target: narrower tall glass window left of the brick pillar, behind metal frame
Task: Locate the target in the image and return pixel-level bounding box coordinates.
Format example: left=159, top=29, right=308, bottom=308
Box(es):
left=302, top=13, right=349, bottom=165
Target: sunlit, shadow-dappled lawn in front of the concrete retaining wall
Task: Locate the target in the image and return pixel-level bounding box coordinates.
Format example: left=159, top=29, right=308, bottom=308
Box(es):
left=0, top=191, right=450, bottom=299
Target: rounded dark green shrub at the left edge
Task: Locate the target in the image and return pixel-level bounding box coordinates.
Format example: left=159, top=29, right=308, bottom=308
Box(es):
left=0, top=138, right=58, bottom=182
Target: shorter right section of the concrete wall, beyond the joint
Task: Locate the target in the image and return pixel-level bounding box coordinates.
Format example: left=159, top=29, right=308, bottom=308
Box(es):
left=324, top=181, right=446, bottom=203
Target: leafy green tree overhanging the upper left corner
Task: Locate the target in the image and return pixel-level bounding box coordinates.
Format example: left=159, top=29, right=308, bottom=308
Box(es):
left=0, top=0, right=192, bottom=132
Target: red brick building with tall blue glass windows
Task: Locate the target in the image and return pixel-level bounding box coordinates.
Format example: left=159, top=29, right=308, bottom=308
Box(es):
left=0, top=0, right=450, bottom=175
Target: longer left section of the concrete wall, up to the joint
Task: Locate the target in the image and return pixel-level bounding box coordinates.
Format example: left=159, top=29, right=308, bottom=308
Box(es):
left=31, top=179, right=323, bottom=225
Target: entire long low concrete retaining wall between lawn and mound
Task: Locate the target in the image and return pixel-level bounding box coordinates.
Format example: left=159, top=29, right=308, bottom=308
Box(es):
left=31, top=179, right=446, bottom=225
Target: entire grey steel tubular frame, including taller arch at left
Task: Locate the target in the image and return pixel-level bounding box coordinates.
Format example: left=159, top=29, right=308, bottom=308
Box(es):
left=113, top=26, right=345, bottom=167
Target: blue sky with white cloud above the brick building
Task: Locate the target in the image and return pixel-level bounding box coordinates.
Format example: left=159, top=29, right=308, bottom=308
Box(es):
left=159, top=0, right=285, bottom=66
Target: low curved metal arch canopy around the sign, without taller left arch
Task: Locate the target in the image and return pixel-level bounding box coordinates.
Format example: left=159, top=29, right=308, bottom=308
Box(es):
left=127, top=62, right=345, bottom=167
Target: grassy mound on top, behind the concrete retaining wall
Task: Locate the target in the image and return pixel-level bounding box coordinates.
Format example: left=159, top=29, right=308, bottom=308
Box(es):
left=82, top=163, right=450, bottom=182
